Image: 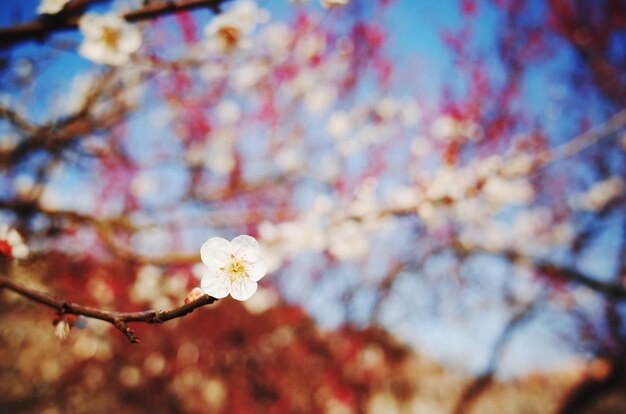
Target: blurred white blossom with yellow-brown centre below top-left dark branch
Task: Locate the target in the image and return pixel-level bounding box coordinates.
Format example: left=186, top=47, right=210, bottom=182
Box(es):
left=78, top=13, right=141, bottom=66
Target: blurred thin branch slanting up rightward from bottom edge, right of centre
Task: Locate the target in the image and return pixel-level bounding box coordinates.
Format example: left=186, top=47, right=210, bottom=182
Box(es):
left=452, top=302, right=535, bottom=414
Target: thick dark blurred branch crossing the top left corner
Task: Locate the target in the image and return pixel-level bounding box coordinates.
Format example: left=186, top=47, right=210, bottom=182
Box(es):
left=0, top=0, right=225, bottom=48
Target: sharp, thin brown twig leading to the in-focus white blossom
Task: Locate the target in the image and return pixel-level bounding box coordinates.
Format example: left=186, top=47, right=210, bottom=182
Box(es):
left=0, top=276, right=218, bottom=343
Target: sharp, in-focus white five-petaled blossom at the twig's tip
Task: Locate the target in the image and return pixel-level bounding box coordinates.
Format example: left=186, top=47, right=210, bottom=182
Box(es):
left=200, top=235, right=267, bottom=300
